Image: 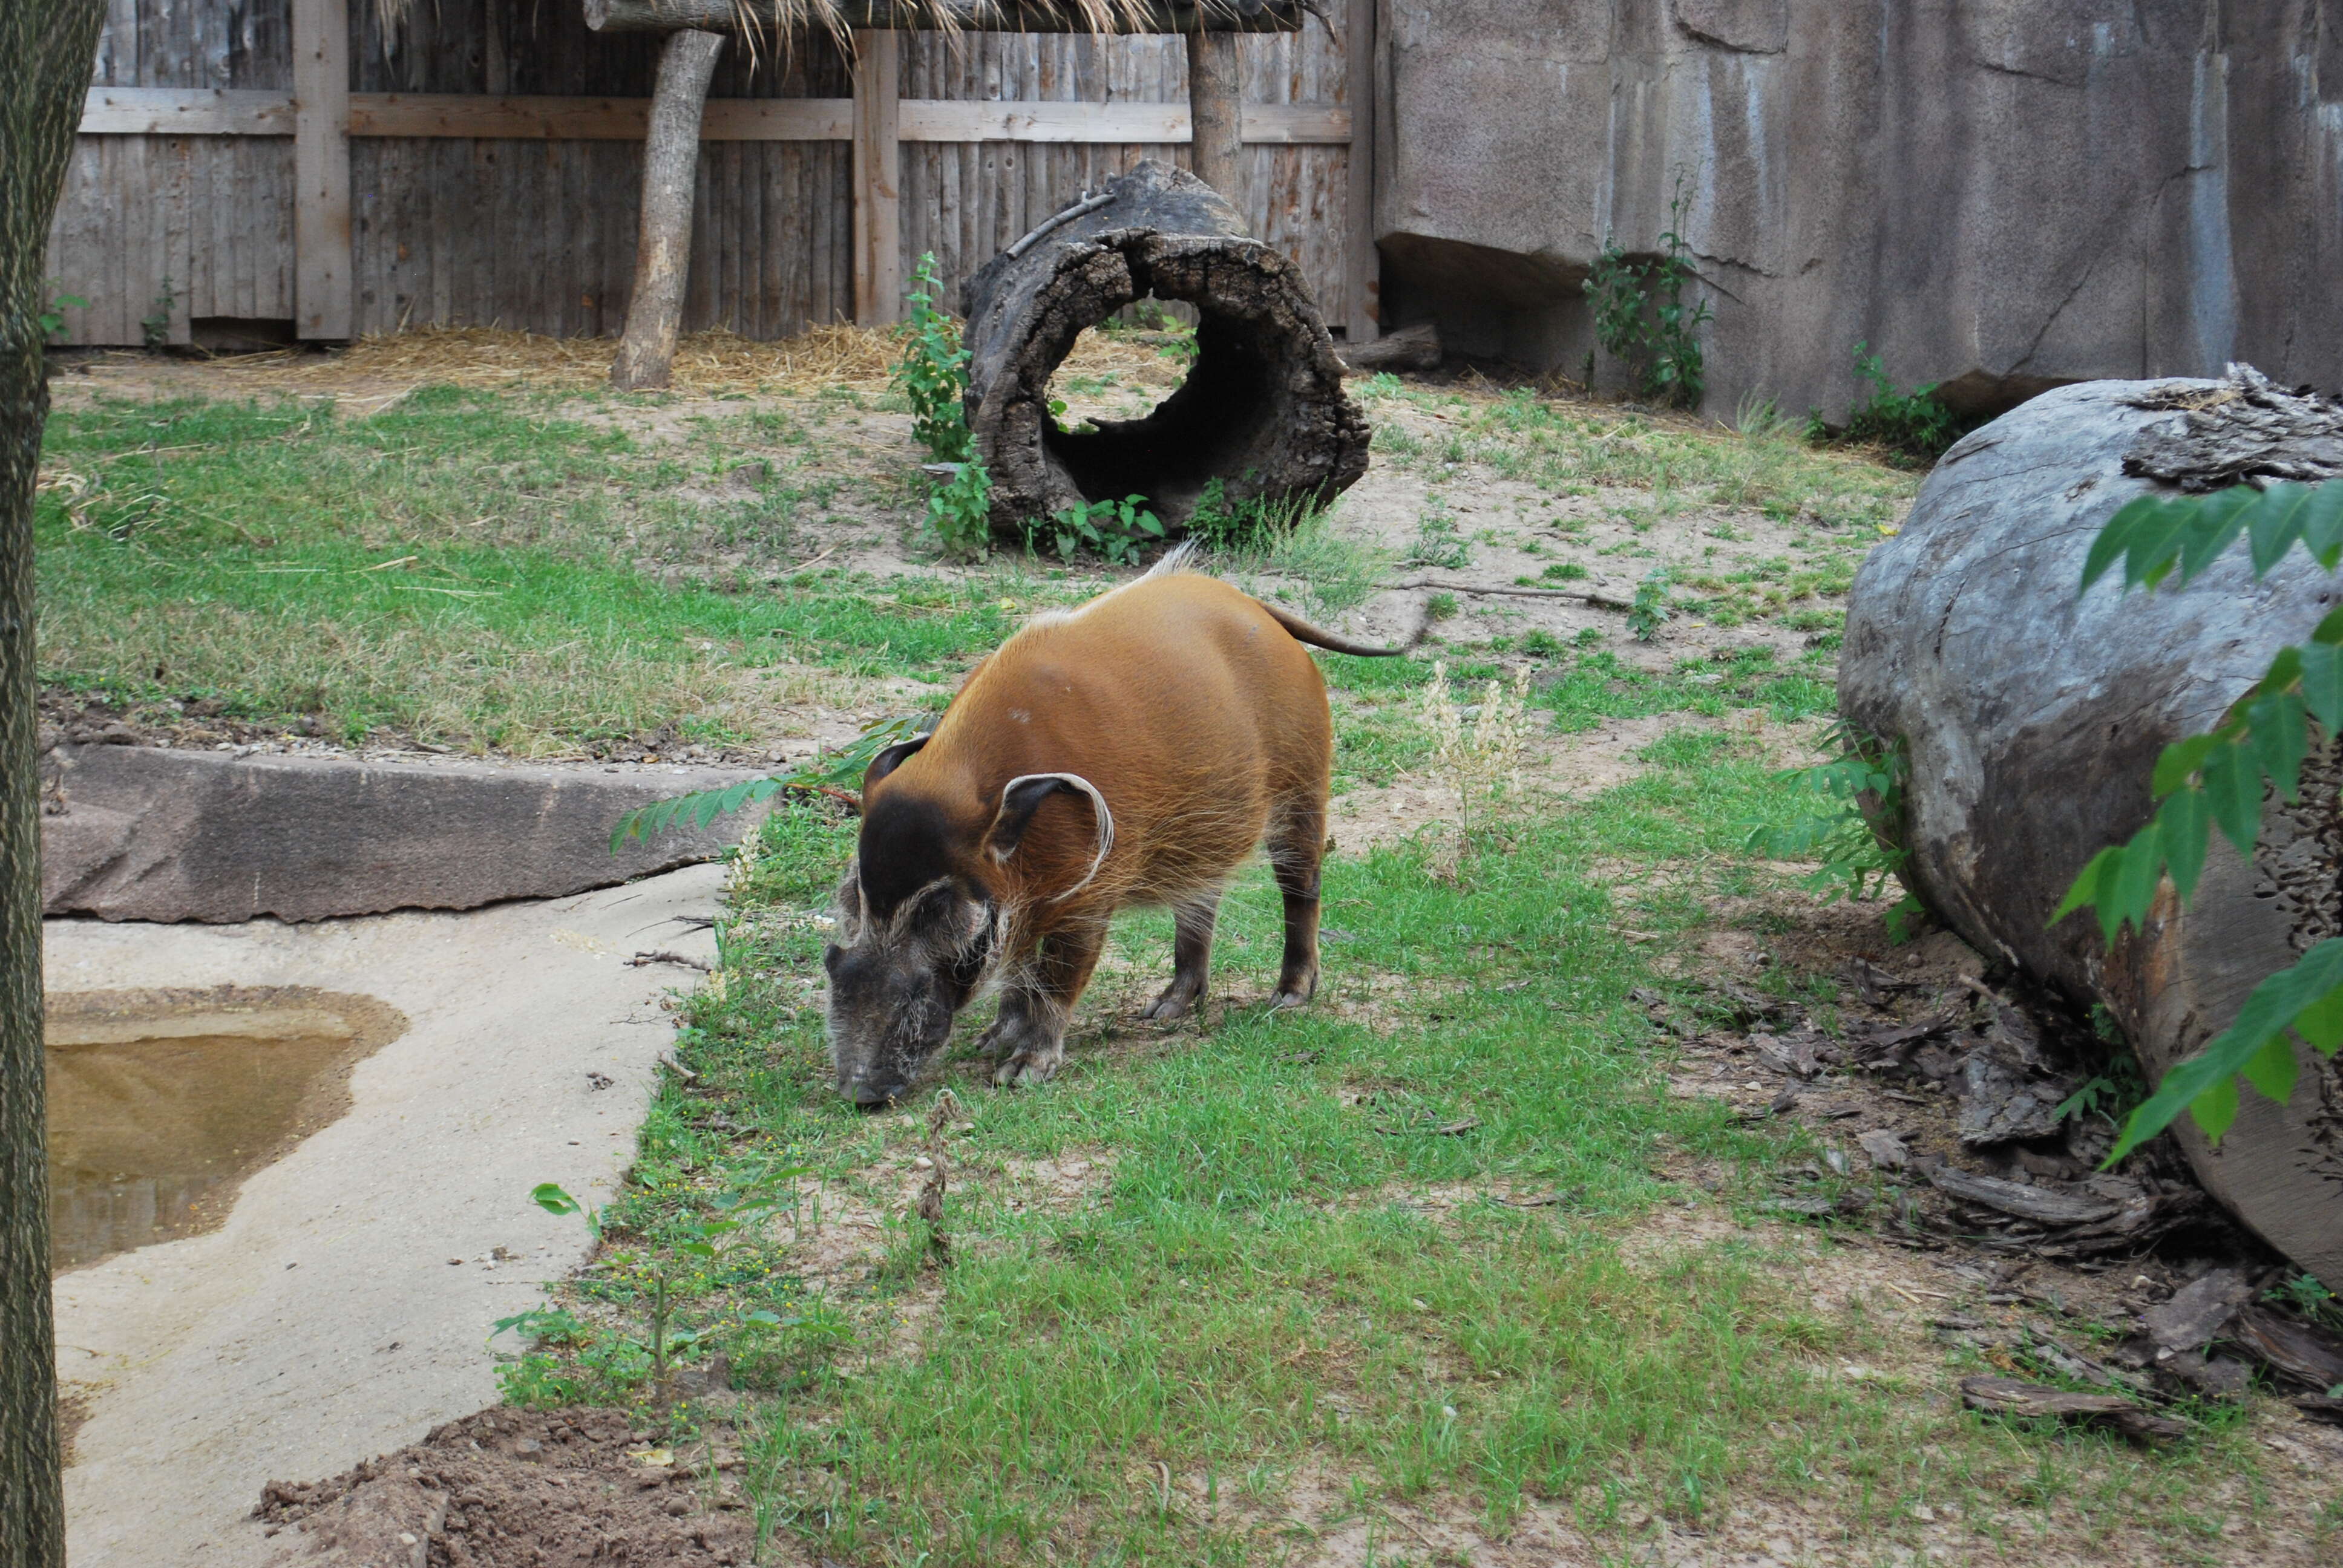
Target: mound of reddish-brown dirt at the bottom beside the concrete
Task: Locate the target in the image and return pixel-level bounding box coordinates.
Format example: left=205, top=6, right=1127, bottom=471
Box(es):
left=255, top=1409, right=755, bottom=1568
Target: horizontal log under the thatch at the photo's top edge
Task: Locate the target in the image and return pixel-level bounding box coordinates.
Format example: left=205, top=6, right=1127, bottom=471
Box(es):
left=586, top=0, right=1309, bottom=33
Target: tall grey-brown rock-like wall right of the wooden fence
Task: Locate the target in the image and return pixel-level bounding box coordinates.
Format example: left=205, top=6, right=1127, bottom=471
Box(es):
left=1375, top=0, right=2343, bottom=417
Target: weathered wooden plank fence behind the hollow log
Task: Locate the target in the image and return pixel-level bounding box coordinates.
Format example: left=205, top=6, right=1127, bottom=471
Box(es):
left=49, top=0, right=1375, bottom=345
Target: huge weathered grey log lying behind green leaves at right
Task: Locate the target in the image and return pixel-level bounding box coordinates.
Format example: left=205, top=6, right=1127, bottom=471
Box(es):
left=1840, top=365, right=2343, bottom=1289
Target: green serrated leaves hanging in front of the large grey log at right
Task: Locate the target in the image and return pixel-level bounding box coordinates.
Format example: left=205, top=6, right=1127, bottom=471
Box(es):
left=2050, top=480, right=2343, bottom=1160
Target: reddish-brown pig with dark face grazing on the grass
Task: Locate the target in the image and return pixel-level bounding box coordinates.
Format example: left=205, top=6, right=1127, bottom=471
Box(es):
left=822, top=550, right=1399, bottom=1104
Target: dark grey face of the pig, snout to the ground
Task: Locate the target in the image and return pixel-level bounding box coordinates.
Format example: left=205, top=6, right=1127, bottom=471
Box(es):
left=822, top=865, right=1000, bottom=1106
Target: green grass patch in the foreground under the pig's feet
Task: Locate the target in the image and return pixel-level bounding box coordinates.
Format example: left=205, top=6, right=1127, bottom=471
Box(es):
left=506, top=750, right=2287, bottom=1566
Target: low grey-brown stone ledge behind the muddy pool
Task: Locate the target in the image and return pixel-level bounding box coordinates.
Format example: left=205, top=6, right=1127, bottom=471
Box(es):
left=40, top=745, right=755, bottom=921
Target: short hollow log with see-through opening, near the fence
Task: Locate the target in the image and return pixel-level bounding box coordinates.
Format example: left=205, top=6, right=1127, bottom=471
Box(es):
left=961, top=159, right=1368, bottom=534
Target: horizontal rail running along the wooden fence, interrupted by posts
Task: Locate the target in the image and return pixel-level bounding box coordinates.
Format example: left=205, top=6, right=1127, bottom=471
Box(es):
left=80, top=87, right=1352, bottom=145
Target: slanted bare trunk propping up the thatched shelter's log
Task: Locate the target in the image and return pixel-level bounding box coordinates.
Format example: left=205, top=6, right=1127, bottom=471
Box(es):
left=609, top=30, right=724, bottom=391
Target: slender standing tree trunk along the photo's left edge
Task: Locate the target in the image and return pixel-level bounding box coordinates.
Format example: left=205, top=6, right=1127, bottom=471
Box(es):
left=0, top=0, right=105, bottom=1568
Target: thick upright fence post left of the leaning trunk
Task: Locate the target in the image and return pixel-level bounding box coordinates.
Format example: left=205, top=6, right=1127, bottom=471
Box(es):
left=293, top=0, right=352, bottom=338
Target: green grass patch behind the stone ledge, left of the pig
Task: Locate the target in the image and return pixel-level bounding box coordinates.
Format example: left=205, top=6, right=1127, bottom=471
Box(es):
left=35, top=389, right=1054, bottom=755
